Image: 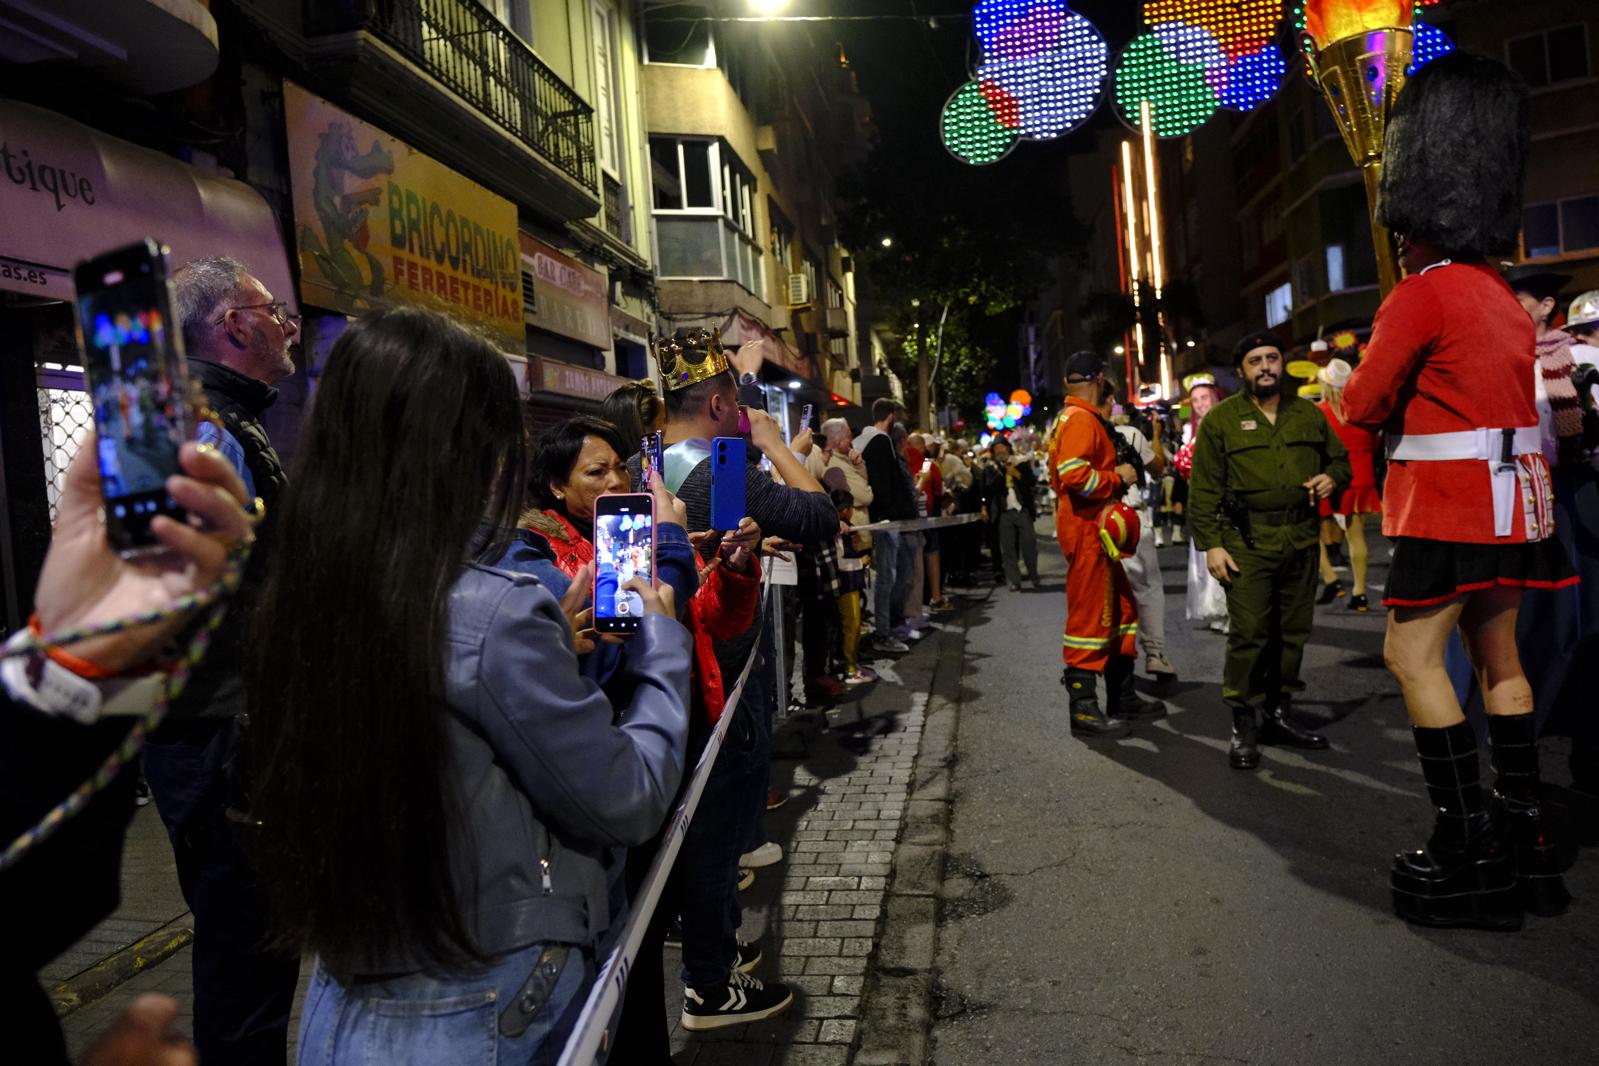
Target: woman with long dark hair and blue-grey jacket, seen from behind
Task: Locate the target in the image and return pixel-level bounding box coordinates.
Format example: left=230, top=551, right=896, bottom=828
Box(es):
left=246, top=303, right=689, bottom=1063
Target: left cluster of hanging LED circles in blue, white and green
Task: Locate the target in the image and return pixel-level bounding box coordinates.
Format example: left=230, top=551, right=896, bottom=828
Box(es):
left=940, top=0, right=1110, bottom=166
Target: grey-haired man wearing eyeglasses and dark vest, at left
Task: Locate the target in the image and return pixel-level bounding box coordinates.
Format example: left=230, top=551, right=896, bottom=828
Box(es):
left=144, top=256, right=299, bottom=1066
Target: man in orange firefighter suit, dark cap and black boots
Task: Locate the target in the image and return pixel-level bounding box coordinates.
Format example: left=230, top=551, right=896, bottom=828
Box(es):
left=1049, top=352, right=1166, bottom=737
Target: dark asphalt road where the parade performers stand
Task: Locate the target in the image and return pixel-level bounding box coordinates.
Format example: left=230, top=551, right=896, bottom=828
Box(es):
left=931, top=535, right=1599, bottom=1066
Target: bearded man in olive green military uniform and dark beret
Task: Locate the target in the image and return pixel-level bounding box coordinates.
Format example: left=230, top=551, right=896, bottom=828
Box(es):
left=1188, top=332, right=1350, bottom=770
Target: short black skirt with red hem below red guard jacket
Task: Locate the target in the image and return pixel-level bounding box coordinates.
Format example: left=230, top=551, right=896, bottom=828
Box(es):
left=1383, top=537, right=1577, bottom=607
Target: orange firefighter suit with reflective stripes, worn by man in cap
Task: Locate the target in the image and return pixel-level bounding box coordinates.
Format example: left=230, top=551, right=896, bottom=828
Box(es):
left=1049, top=396, right=1138, bottom=673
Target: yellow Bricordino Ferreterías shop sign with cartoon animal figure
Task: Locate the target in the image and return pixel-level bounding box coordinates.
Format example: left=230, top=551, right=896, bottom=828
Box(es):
left=283, top=82, right=526, bottom=352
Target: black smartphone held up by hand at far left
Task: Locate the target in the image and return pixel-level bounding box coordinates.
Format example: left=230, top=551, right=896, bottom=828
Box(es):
left=72, top=238, right=193, bottom=558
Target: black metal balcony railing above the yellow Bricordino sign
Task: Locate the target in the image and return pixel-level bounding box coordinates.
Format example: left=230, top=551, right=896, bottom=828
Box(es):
left=305, top=0, right=596, bottom=190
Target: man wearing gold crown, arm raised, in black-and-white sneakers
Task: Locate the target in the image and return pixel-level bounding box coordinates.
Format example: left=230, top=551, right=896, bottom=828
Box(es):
left=628, top=329, right=838, bottom=1031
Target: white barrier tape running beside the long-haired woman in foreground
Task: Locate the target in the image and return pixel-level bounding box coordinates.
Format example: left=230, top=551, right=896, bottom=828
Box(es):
left=558, top=571, right=771, bottom=1066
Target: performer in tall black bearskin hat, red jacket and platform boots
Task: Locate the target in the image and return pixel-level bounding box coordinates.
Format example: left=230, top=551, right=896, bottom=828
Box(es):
left=1343, top=53, right=1575, bottom=929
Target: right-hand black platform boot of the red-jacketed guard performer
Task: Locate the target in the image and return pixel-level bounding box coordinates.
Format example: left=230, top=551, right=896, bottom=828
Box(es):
left=1489, top=714, right=1577, bottom=917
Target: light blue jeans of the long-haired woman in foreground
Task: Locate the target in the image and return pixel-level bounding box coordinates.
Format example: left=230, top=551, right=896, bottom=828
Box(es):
left=299, top=945, right=595, bottom=1066
